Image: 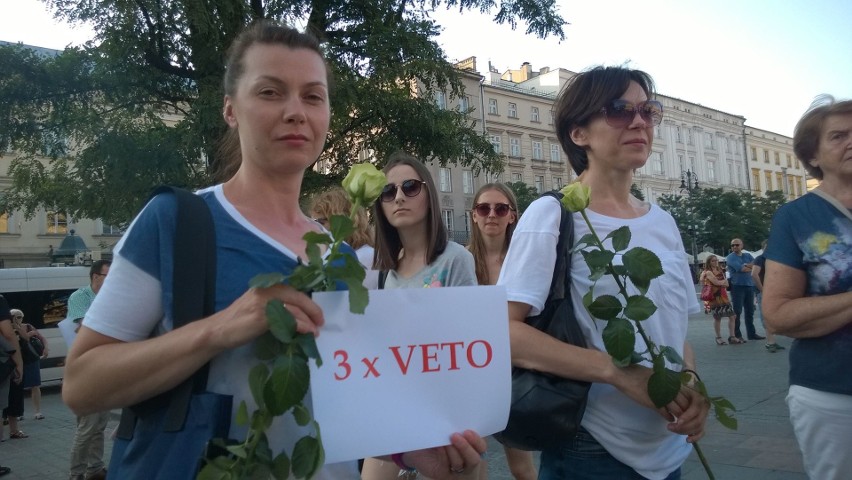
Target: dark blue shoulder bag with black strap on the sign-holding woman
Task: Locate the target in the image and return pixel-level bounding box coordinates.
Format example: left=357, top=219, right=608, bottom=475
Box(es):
left=109, top=187, right=232, bottom=480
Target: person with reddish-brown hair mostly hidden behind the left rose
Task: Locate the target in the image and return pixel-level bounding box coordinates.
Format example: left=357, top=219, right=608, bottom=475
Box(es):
left=308, top=187, right=379, bottom=290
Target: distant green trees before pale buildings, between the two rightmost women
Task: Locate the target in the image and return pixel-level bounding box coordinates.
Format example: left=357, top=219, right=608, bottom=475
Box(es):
left=658, top=188, right=785, bottom=254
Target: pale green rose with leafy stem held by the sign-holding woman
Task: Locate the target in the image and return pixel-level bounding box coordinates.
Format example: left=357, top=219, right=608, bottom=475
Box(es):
left=198, top=163, right=387, bottom=480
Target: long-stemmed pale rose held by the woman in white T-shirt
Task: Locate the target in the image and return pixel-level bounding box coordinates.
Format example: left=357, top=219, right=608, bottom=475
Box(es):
left=561, top=182, right=737, bottom=479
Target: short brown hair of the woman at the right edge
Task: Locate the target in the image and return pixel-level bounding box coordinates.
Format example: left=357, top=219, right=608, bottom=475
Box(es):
left=793, top=95, right=852, bottom=180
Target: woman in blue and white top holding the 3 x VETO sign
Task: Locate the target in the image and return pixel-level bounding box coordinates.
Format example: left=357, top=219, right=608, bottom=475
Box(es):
left=62, top=20, right=486, bottom=480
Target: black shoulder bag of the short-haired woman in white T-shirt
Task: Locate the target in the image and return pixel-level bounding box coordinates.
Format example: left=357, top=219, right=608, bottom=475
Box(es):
left=494, top=192, right=591, bottom=450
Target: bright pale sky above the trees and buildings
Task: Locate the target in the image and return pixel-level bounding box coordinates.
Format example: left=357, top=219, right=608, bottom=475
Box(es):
left=0, top=0, right=852, bottom=136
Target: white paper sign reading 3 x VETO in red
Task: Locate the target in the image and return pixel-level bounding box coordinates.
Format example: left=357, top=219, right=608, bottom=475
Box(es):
left=311, top=286, right=511, bottom=463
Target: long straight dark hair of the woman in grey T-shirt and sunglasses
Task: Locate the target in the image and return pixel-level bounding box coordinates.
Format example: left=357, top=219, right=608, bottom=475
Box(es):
left=373, top=151, right=449, bottom=270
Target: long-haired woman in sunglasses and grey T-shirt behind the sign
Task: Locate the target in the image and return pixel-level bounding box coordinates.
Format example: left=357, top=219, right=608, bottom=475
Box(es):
left=361, top=152, right=480, bottom=480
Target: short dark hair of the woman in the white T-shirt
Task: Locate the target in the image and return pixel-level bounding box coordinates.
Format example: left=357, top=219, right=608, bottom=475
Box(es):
left=553, top=66, right=655, bottom=175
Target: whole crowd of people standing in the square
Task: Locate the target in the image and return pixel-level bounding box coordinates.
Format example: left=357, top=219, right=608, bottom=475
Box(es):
left=0, top=16, right=852, bottom=480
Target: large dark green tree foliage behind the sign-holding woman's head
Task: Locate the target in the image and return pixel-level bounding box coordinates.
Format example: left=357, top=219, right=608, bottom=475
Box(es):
left=0, top=0, right=565, bottom=225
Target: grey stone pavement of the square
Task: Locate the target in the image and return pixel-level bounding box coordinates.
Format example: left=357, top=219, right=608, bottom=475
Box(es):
left=0, top=314, right=807, bottom=480
